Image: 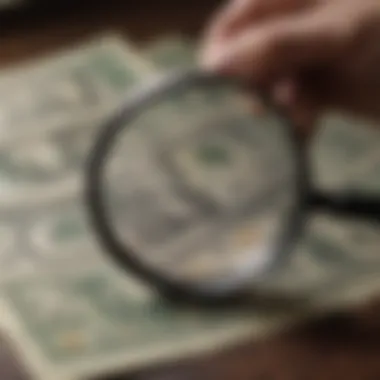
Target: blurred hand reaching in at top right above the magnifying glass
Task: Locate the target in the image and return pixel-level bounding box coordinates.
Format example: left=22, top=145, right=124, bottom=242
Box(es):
left=201, top=0, right=380, bottom=133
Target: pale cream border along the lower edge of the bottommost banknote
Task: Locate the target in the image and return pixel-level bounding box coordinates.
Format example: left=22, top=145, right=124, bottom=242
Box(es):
left=0, top=288, right=295, bottom=380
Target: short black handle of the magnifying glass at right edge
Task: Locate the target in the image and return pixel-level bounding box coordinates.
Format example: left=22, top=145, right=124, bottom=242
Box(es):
left=309, top=192, right=380, bottom=222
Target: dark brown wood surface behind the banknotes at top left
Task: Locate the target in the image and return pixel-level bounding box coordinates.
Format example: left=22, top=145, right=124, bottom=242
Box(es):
left=0, top=0, right=221, bottom=66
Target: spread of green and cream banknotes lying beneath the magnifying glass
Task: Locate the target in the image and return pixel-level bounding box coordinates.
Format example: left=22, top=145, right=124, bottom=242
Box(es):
left=0, top=35, right=380, bottom=380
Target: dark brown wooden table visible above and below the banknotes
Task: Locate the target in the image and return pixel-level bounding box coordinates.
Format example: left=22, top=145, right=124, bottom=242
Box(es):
left=0, top=0, right=380, bottom=380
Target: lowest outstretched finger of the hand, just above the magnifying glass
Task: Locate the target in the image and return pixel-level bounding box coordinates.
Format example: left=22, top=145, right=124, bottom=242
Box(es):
left=203, top=10, right=351, bottom=81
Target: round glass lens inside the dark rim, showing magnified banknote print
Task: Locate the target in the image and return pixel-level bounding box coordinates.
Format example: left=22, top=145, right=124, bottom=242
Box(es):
left=99, top=75, right=297, bottom=289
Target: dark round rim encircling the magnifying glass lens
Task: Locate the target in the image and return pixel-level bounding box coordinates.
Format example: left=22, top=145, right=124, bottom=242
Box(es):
left=85, top=68, right=309, bottom=304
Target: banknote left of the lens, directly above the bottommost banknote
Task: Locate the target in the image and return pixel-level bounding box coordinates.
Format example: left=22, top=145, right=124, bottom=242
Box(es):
left=0, top=194, right=99, bottom=287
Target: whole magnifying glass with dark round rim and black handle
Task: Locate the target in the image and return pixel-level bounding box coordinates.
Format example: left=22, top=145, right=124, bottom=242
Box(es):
left=86, top=69, right=380, bottom=304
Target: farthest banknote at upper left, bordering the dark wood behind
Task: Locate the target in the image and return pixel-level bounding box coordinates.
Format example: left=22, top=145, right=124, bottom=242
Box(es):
left=0, top=35, right=153, bottom=146
